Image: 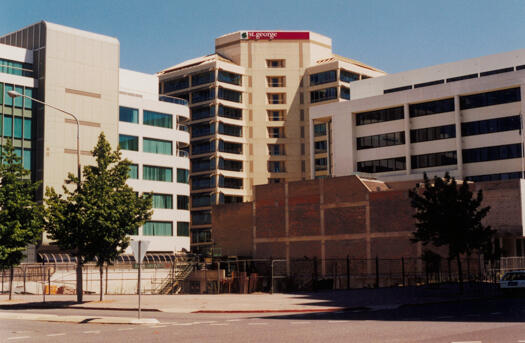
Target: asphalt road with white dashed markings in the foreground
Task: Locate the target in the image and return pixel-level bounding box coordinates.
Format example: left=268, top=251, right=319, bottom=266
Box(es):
left=0, top=298, right=525, bottom=343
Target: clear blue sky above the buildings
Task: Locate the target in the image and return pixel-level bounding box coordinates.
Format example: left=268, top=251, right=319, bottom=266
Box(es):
left=0, top=0, right=525, bottom=73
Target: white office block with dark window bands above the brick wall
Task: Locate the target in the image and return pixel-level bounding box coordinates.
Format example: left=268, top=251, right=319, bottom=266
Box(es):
left=310, top=49, right=525, bottom=181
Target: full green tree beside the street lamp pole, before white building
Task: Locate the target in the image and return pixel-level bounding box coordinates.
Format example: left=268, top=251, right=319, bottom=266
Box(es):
left=46, top=133, right=152, bottom=302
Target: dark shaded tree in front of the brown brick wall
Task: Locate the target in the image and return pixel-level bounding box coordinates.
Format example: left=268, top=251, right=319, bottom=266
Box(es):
left=409, top=172, right=495, bottom=290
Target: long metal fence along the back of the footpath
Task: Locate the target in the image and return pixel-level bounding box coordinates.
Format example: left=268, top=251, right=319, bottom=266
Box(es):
left=0, top=257, right=525, bottom=294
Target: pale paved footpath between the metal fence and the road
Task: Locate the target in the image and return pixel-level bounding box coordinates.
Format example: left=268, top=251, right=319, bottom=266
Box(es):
left=0, top=285, right=499, bottom=324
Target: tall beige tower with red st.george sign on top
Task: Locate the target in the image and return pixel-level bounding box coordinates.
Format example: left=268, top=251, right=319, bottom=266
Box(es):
left=158, top=31, right=384, bottom=252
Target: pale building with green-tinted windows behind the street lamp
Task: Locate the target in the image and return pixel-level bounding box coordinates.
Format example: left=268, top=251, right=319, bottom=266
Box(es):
left=0, top=21, right=189, bottom=261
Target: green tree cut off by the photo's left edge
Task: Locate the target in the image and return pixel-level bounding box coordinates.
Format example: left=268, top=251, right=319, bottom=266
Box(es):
left=0, top=139, right=44, bottom=300
